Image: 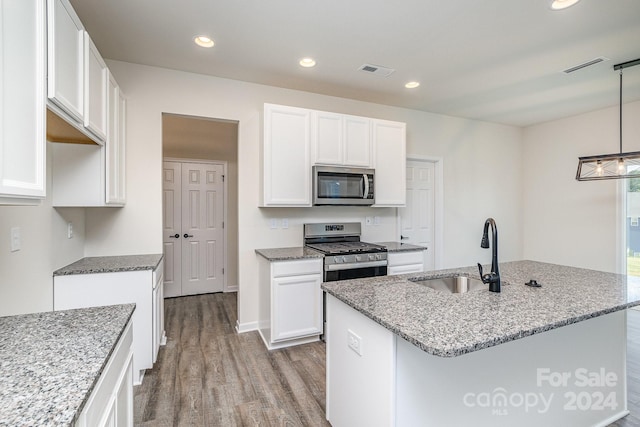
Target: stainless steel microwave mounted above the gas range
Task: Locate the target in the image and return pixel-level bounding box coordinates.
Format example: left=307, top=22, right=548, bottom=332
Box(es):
left=313, top=166, right=375, bottom=206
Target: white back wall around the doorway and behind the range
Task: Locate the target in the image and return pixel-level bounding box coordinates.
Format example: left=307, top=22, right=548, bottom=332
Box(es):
left=85, top=61, right=522, bottom=325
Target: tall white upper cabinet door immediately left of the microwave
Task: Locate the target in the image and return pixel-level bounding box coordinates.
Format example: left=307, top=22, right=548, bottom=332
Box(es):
left=260, top=104, right=311, bottom=206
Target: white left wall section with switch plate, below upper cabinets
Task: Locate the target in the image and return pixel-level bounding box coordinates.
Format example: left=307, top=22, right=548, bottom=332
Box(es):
left=0, top=145, right=85, bottom=316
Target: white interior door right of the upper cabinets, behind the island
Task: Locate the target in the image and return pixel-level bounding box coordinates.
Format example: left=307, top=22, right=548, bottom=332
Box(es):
left=398, top=160, right=435, bottom=270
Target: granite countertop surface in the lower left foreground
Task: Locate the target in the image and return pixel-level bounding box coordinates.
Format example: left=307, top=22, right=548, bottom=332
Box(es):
left=0, top=304, right=135, bottom=426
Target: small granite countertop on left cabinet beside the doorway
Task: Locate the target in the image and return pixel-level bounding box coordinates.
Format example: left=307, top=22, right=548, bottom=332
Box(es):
left=53, top=254, right=162, bottom=276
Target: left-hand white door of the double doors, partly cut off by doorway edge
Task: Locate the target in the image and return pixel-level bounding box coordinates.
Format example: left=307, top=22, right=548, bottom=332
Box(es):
left=162, top=162, right=183, bottom=298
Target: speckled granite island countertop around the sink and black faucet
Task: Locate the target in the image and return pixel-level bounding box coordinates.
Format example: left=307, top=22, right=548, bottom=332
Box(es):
left=322, top=261, right=640, bottom=357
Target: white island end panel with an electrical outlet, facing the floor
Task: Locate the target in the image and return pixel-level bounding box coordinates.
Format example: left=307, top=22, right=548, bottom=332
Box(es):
left=325, top=294, right=395, bottom=427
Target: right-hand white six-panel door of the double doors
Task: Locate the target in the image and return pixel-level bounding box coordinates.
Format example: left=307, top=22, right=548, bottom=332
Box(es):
left=182, top=163, right=224, bottom=295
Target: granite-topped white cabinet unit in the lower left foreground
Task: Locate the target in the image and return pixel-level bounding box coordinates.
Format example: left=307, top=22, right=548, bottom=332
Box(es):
left=0, top=304, right=135, bottom=426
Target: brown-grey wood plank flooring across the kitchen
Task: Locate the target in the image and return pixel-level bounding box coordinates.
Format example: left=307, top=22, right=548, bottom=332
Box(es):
left=134, top=293, right=640, bottom=427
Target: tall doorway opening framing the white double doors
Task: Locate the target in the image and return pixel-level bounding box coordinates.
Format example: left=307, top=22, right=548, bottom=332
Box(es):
left=162, top=113, right=238, bottom=297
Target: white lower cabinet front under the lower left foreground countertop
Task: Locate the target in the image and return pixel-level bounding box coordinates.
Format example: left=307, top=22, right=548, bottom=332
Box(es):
left=76, top=321, right=133, bottom=427
